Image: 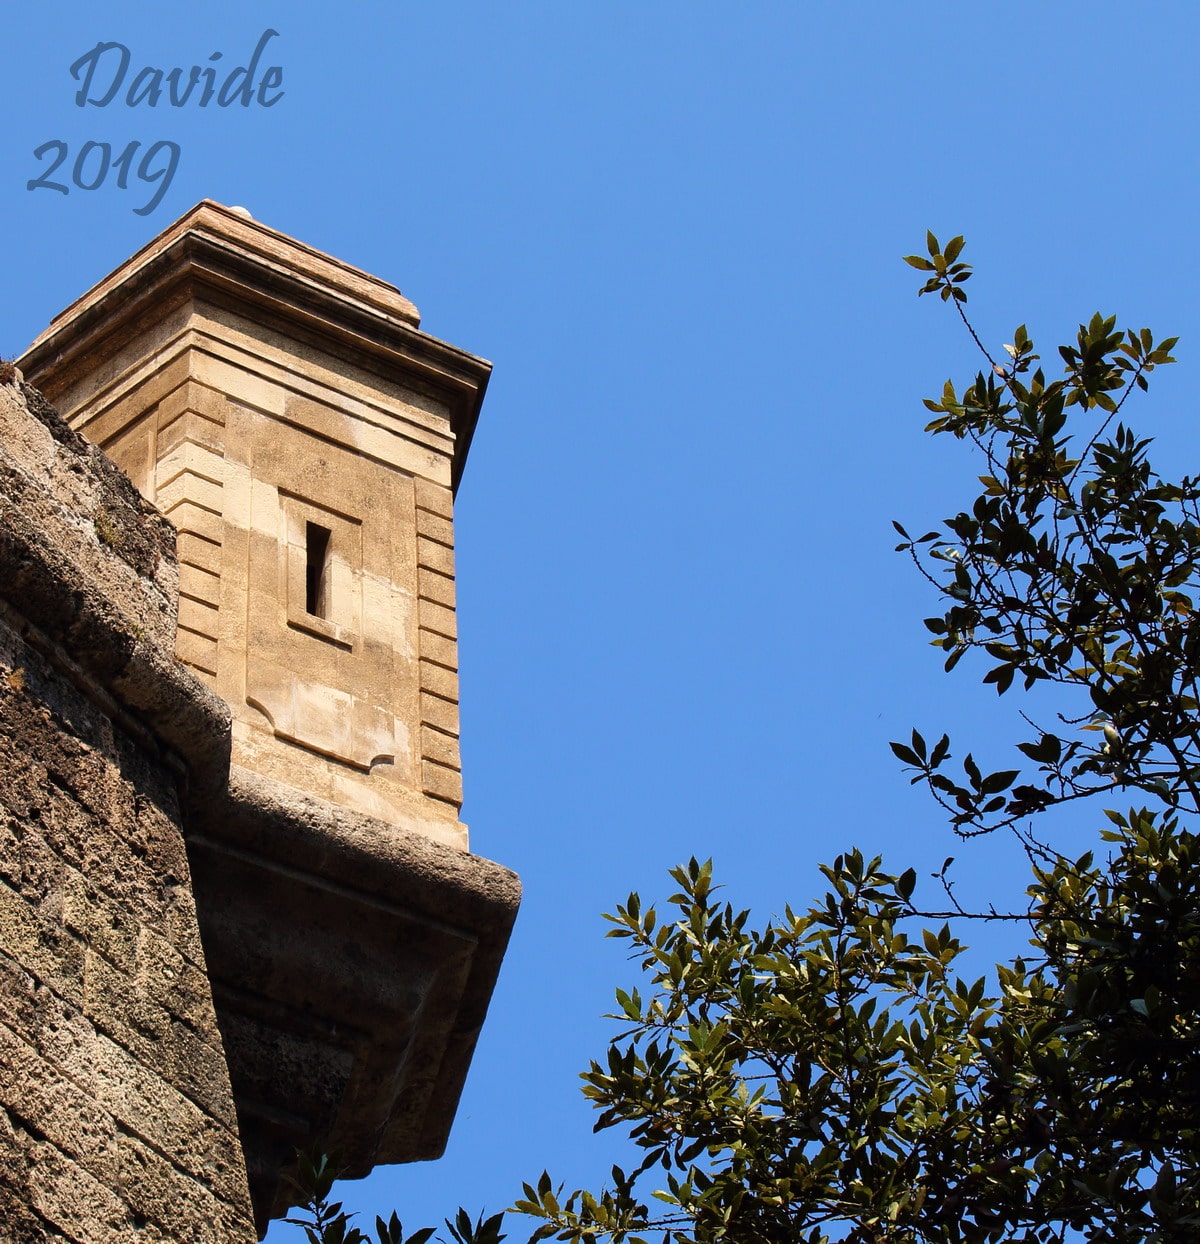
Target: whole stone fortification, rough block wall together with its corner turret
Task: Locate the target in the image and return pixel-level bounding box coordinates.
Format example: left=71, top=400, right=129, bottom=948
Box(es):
left=0, top=203, right=520, bottom=1244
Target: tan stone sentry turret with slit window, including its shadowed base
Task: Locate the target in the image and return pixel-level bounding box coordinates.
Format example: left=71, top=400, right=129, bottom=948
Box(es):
left=5, top=202, right=519, bottom=1232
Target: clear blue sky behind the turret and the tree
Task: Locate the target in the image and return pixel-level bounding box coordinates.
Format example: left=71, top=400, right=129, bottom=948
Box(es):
left=0, top=0, right=1200, bottom=1244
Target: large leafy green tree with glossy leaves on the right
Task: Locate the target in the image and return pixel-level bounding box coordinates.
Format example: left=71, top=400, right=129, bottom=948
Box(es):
left=516, top=234, right=1200, bottom=1244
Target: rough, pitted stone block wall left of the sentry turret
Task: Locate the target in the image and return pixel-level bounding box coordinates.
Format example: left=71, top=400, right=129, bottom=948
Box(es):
left=0, top=376, right=255, bottom=1244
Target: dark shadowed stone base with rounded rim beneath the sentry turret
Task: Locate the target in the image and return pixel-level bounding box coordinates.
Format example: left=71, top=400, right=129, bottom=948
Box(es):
left=188, top=768, right=521, bottom=1227
